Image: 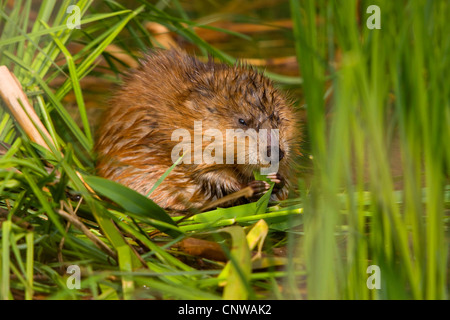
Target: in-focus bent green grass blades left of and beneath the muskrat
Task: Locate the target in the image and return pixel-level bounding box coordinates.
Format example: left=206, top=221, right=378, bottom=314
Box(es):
left=0, top=0, right=300, bottom=299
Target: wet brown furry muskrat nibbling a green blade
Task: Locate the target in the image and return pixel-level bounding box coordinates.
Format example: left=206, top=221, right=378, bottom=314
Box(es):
left=95, top=49, right=300, bottom=211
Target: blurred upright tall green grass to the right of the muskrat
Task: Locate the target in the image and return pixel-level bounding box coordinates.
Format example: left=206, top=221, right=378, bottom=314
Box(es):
left=291, top=0, right=450, bottom=299
